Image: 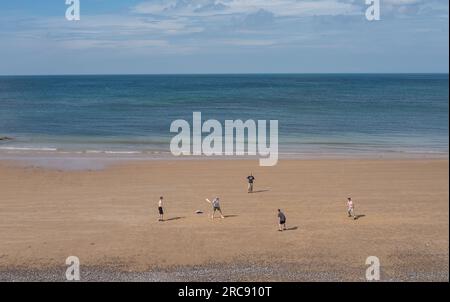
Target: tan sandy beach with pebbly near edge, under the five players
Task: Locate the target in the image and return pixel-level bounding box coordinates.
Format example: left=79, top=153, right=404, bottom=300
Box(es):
left=0, top=159, right=449, bottom=281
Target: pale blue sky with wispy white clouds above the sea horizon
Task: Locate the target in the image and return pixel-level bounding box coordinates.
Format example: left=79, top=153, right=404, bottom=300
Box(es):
left=0, top=0, right=449, bottom=75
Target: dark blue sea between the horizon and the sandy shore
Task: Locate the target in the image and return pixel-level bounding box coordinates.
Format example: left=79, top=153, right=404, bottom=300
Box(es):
left=0, top=74, right=449, bottom=154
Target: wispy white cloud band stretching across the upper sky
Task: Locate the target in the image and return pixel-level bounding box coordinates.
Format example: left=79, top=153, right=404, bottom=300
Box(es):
left=0, top=0, right=448, bottom=53
